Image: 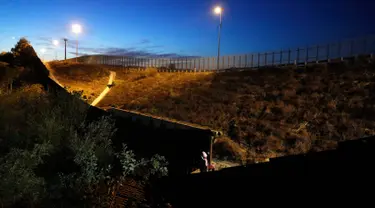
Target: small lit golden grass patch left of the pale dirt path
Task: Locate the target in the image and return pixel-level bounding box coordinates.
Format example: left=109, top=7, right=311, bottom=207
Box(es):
left=48, top=62, right=110, bottom=103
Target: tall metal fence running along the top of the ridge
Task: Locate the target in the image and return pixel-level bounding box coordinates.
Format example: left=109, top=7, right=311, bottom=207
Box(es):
left=74, top=35, right=375, bottom=71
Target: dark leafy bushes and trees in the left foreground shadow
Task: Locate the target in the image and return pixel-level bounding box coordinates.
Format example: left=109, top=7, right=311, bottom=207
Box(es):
left=0, top=39, right=167, bottom=207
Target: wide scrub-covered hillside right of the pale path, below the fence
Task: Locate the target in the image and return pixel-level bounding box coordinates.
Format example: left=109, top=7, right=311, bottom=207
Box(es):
left=50, top=58, right=375, bottom=159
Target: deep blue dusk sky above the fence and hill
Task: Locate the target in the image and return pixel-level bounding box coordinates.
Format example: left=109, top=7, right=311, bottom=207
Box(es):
left=0, top=0, right=375, bottom=59
